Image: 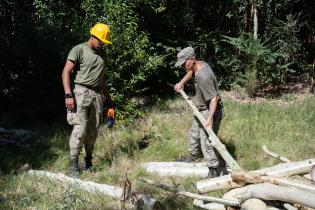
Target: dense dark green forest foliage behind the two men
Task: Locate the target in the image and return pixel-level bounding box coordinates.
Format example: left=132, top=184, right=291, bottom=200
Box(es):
left=0, top=0, right=315, bottom=124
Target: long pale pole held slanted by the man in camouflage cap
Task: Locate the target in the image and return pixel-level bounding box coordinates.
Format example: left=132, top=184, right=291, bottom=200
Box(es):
left=180, top=90, right=242, bottom=170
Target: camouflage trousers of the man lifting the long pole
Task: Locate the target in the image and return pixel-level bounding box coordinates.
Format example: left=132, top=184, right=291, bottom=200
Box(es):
left=188, top=109, right=225, bottom=168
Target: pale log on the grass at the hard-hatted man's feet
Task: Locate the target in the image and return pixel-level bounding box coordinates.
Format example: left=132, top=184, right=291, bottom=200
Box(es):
left=28, top=170, right=160, bottom=209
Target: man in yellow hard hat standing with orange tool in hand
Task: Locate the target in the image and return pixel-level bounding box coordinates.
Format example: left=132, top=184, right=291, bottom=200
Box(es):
left=62, top=23, right=112, bottom=178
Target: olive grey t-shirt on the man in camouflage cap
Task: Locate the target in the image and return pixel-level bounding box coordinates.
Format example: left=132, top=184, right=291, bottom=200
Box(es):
left=194, top=61, right=219, bottom=110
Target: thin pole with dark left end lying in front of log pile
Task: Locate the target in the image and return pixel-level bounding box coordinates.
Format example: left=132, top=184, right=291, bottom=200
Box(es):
left=138, top=177, right=240, bottom=206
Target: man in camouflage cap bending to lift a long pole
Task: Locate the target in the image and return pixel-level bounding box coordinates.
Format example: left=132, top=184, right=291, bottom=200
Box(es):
left=174, top=47, right=225, bottom=177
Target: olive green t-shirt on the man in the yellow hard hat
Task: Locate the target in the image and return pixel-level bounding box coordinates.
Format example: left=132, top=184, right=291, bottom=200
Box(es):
left=67, top=42, right=105, bottom=87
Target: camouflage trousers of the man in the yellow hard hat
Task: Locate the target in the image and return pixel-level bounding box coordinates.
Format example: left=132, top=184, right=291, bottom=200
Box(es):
left=67, top=85, right=104, bottom=159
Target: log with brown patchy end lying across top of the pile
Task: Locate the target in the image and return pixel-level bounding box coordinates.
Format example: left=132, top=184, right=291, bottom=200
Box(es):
left=231, top=171, right=315, bottom=194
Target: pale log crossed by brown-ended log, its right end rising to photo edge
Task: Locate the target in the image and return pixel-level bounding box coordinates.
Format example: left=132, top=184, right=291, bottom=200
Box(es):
left=196, top=159, right=315, bottom=193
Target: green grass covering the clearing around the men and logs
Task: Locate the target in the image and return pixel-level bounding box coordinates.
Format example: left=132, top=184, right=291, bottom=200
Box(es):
left=0, top=95, right=315, bottom=209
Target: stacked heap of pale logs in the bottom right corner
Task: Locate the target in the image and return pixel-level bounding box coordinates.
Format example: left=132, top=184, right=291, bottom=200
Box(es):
left=197, top=146, right=315, bottom=210
